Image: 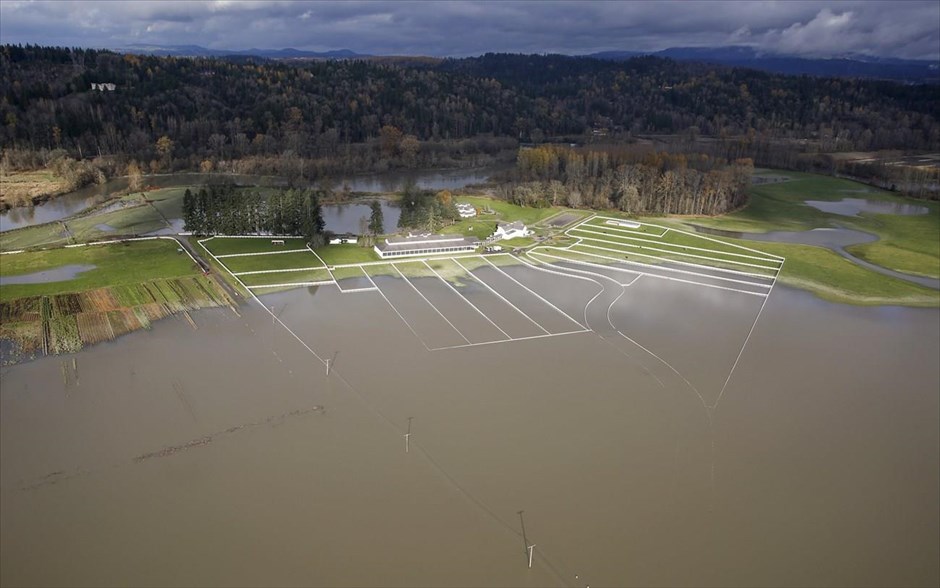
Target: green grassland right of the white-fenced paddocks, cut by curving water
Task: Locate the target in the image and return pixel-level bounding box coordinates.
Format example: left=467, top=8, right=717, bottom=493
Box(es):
left=649, top=172, right=940, bottom=306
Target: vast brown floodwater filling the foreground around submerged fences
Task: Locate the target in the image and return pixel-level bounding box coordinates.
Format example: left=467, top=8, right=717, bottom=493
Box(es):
left=0, top=266, right=940, bottom=586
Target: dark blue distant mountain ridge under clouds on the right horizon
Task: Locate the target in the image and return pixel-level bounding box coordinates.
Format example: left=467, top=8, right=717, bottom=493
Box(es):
left=586, top=45, right=940, bottom=83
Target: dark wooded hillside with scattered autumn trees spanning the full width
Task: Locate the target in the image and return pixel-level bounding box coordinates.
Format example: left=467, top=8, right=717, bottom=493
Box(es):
left=0, top=45, right=940, bottom=178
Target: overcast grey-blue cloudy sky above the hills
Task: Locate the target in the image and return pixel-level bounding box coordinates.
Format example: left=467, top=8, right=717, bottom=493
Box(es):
left=0, top=0, right=940, bottom=59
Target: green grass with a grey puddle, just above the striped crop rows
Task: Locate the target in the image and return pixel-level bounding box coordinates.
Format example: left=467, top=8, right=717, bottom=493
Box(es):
left=0, top=239, right=199, bottom=300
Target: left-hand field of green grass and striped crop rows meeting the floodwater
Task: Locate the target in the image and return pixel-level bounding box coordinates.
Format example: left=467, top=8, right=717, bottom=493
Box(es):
left=0, top=240, right=232, bottom=362
